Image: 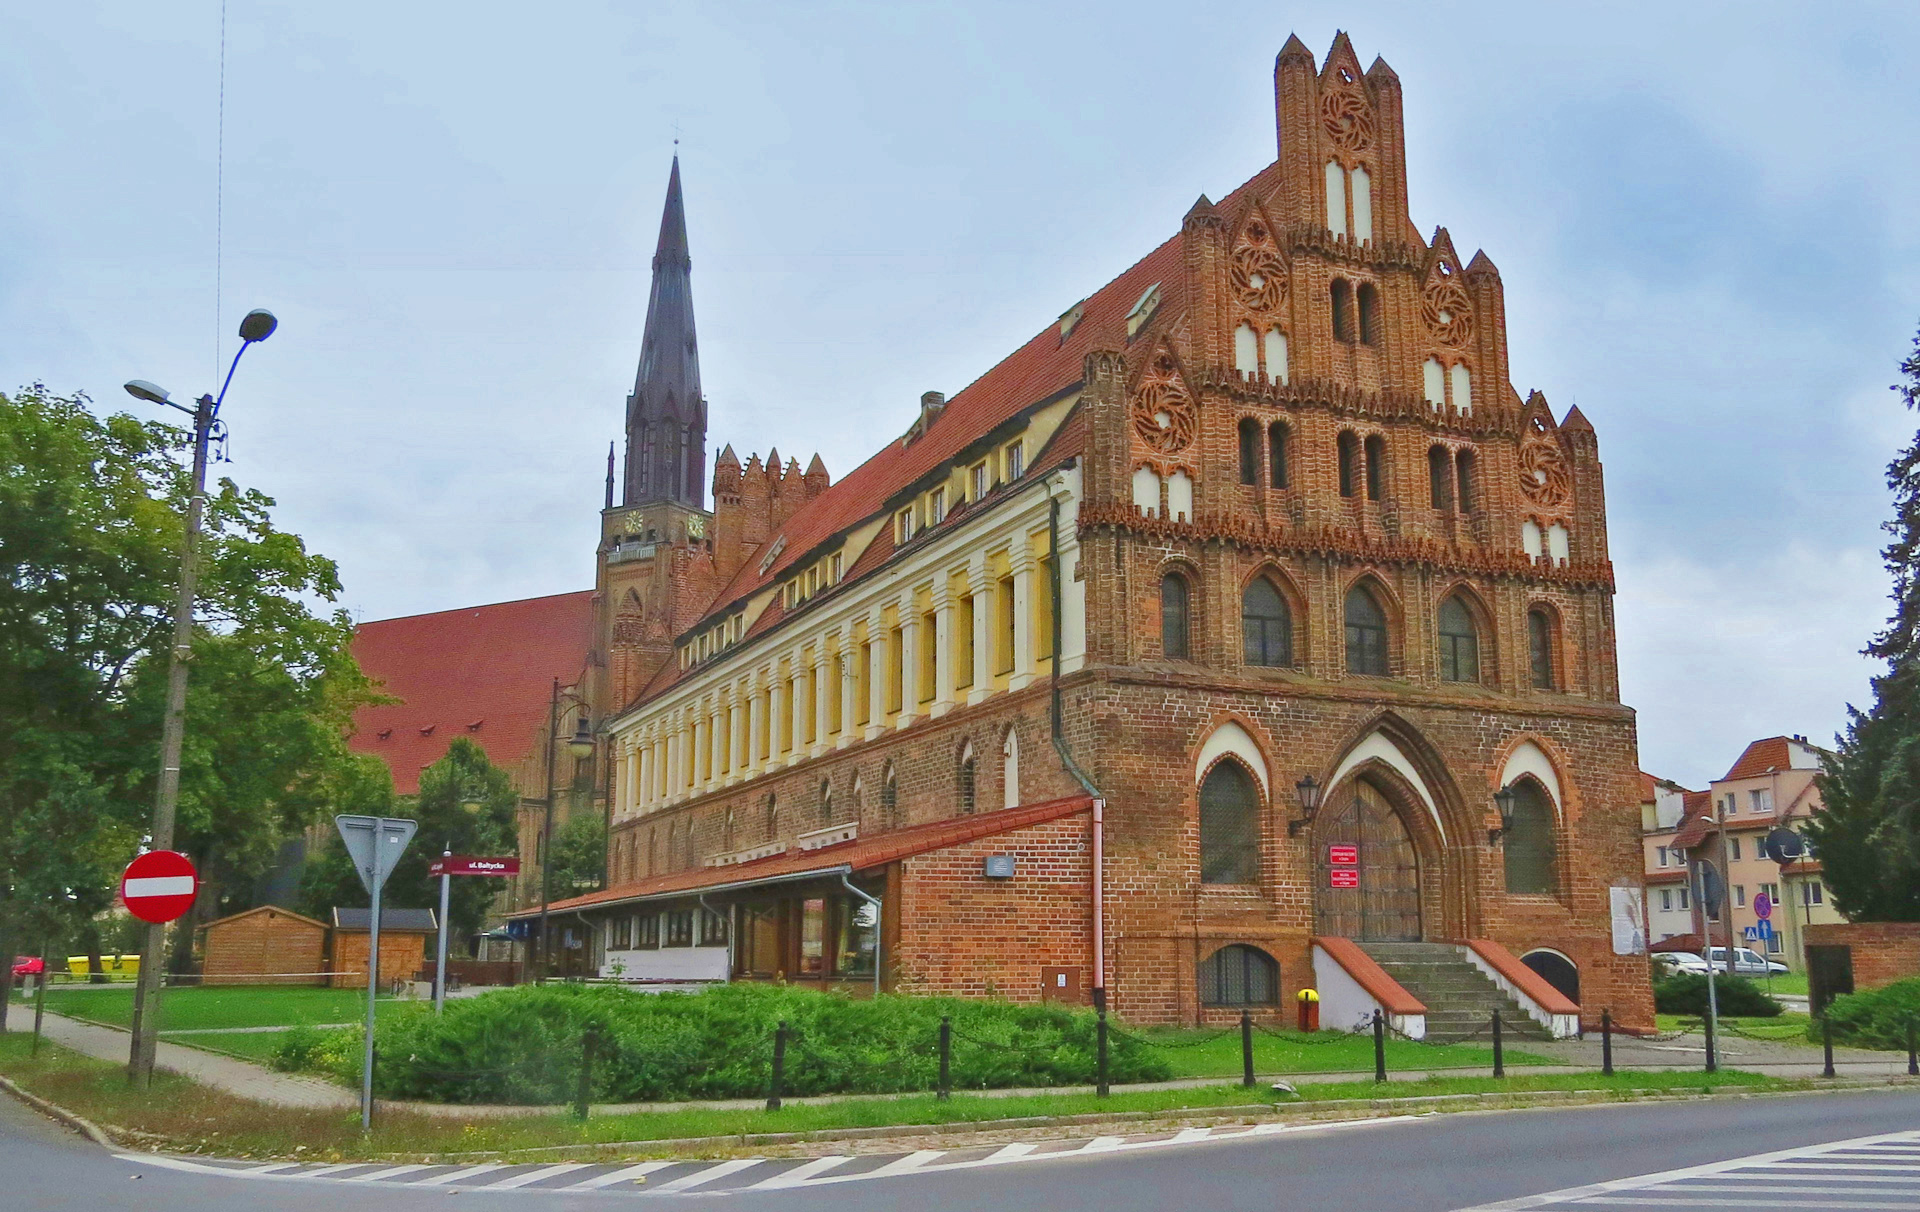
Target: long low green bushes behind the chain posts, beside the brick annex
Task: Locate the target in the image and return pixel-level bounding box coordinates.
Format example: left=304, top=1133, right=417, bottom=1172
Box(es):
left=275, top=983, right=1171, bottom=1104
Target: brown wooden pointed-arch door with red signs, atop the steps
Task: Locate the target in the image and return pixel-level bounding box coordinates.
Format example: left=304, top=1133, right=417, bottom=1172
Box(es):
left=1313, top=778, right=1421, bottom=943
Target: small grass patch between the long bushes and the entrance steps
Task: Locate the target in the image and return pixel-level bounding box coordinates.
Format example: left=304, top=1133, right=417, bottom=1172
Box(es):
left=1139, top=1030, right=1555, bottom=1078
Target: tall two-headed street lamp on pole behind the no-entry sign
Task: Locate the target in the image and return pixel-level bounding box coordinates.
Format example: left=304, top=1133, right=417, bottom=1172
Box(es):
left=127, top=309, right=280, bottom=1089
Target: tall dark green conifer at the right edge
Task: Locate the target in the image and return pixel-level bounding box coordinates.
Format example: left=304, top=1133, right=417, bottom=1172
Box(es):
left=1807, top=324, right=1920, bottom=922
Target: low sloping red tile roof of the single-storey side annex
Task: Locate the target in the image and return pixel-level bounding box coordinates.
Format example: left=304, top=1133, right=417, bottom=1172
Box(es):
left=507, top=795, right=1092, bottom=918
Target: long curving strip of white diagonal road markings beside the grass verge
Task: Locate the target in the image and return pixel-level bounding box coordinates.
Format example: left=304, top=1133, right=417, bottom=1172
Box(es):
left=115, top=1116, right=1413, bottom=1206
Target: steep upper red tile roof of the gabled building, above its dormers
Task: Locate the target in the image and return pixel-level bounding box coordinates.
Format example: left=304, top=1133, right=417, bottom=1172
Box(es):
left=683, top=163, right=1279, bottom=641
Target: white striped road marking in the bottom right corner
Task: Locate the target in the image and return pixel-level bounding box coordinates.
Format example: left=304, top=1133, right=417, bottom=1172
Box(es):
left=1459, top=1131, right=1920, bottom=1212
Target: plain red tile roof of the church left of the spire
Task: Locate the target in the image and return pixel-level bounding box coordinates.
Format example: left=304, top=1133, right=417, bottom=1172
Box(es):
left=348, top=590, right=593, bottom=795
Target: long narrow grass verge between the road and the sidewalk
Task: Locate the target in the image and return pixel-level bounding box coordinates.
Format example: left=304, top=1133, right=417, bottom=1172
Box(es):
left=0, top=1033, right=1789, bottom=1162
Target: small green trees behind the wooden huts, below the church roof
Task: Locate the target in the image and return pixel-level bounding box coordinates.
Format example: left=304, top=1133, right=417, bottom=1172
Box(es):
left=300, top=736, right=520, bottom=937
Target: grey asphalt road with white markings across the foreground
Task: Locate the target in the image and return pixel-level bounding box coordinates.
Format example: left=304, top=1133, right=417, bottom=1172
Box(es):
left=0, top=1091, right=1920, bottom=1212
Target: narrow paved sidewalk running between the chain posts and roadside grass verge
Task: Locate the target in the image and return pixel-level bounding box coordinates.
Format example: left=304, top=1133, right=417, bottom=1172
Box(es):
left=11, top=1014, right=1907, bottom=1120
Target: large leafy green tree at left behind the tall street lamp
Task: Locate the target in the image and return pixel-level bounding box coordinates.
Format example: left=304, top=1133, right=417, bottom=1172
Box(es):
left=0, top=384, right=374, bottom=964
